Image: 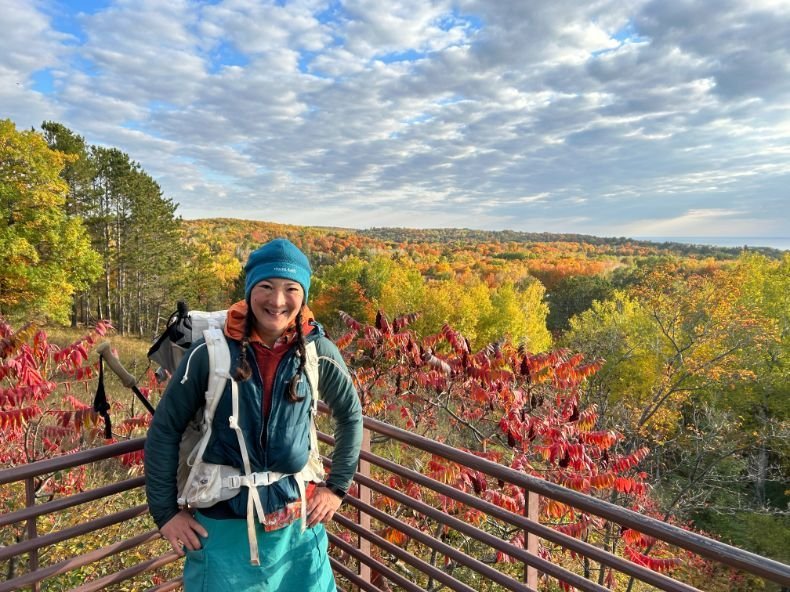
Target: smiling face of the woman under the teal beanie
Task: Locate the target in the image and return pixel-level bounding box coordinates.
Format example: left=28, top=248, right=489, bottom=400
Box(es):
left=250, top=278, right=304, bottom=347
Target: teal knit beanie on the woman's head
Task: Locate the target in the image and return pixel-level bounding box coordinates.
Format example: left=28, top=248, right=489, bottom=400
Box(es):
left=244, top=238, right=312, bottom=302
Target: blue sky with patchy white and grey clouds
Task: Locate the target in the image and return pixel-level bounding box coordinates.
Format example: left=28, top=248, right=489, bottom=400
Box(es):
left=0, top=0, right=790, bottom=237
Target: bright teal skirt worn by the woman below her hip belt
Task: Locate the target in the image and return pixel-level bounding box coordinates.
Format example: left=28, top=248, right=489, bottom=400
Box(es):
left=184, top=512, right=336, bottom=592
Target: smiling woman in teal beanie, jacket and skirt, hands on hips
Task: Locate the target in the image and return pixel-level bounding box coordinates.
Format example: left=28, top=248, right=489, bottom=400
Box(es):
left=145, top=239, right=362, bottom=592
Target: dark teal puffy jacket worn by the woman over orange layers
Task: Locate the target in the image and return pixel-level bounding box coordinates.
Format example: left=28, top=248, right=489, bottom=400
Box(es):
left=145, top=323, right=362, bottom=527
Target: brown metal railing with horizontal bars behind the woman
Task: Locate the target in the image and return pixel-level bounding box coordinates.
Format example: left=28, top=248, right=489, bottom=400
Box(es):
left=0, top=418, right=790, bottom=592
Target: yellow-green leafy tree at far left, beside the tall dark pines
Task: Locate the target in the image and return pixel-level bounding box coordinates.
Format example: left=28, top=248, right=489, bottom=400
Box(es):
left=0, top=120, right=99, bottom=322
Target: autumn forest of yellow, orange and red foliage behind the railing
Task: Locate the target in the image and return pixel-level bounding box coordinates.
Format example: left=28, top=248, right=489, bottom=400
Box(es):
left=0, top=120, right=790, bottom=590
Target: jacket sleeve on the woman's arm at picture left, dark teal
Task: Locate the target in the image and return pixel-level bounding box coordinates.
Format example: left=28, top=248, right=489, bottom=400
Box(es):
left=145, top=340, right=208, bottom=528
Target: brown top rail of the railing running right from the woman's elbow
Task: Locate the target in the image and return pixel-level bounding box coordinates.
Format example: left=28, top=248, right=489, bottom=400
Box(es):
left=363, top=417, right=790, bottom=586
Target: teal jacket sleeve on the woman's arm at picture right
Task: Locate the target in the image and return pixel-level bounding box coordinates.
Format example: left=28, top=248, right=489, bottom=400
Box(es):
left=318, top=338, right=362, bottom=492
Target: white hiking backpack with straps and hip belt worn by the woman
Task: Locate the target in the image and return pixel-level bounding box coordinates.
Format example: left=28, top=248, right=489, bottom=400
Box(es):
left=169, top=310, right=324, bottom=565
